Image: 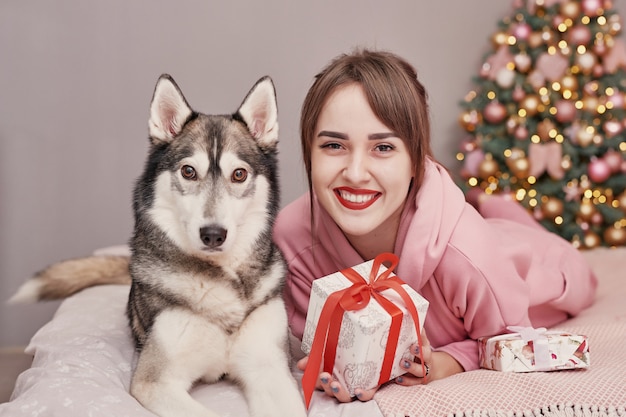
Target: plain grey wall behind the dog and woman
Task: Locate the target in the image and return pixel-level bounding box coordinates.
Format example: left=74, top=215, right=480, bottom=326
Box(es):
left=0, top=0, right=626, bottom=347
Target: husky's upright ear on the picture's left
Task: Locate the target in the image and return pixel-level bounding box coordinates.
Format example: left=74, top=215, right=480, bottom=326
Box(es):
left=149, top=74, right=193, bottom=143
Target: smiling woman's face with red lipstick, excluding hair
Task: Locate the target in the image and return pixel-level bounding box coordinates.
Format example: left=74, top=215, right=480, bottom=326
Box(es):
left=311, top=83, right=413, bottom=247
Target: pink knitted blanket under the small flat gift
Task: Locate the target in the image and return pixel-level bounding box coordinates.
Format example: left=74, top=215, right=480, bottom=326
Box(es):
left=375, top=249, right=626, bottom=417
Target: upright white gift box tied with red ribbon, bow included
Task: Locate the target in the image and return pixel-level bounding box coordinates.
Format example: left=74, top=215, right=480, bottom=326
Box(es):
left=302, top=253, right=428, bottom=405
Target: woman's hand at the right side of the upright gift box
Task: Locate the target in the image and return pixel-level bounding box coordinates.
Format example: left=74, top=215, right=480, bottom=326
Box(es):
left=396, top=330, right=463, bottom=386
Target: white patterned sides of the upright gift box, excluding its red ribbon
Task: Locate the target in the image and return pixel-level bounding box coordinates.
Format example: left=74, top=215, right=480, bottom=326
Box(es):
left=302, top=258, right=428, bottom=395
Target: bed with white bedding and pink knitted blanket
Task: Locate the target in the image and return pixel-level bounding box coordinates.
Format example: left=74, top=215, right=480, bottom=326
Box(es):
left=0, top=248, right=626, bottom=417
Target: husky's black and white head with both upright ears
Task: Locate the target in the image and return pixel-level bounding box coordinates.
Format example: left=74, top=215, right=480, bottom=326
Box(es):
left=135, top=75, right=279, bottom=258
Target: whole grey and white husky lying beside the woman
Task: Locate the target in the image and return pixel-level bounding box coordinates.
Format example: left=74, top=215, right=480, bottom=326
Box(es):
left=14, top=75, right=306, bottom=417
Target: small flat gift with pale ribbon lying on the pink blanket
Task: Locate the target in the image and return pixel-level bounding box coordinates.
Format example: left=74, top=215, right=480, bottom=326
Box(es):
left=478, top=326, right=589, bottom=372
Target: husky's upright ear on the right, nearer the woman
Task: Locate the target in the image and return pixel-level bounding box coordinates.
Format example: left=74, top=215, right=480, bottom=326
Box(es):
left=237, top=76, right=278, bottom=148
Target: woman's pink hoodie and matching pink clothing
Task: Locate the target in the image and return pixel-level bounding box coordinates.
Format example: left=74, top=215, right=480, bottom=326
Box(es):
left=274, top=161, right=597, bottom=370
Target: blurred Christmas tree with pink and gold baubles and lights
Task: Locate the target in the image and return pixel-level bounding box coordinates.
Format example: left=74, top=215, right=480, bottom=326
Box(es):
left=457, top=0, right=626, bottom=248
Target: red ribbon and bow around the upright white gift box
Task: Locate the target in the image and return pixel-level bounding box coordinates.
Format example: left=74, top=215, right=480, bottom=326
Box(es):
left=302, top=253, right=426, bottom=408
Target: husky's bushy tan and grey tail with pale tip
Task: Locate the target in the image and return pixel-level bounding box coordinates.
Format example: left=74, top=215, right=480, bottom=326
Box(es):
left=8, top=256, right=131, bottom=304
